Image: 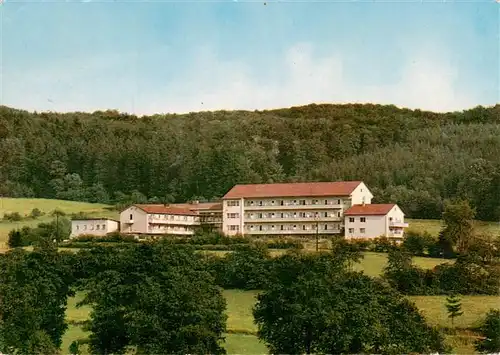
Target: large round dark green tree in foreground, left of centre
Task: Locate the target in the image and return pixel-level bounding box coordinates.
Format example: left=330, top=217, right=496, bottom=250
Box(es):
left=79, top=243, right=226, bottom=354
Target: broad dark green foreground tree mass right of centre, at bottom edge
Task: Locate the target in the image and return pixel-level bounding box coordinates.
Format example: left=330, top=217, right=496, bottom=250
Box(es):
left=254, top=255, right=446, bottom=354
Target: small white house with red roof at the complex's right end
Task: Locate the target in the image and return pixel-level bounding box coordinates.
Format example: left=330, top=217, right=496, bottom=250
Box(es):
left=344, top=204, right=408, bottom=241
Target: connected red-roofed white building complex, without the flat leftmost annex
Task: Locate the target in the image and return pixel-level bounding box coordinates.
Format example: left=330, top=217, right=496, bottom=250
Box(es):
left=115, top=181, right=408, bottom=238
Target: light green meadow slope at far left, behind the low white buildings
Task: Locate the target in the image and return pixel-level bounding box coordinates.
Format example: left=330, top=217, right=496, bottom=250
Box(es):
left=0, top=197, right=119, bottom=250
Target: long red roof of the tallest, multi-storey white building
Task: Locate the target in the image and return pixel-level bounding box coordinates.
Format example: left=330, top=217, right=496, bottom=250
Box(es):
left=223, top=181, right=361, bottom=199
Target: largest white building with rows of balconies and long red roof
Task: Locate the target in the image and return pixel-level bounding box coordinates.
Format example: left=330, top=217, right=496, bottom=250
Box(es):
left=222, top=181, right=364, bottom=235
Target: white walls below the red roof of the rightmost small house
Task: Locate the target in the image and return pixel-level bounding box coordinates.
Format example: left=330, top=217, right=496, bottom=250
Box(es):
left=344, top=205, right=408, bottom=239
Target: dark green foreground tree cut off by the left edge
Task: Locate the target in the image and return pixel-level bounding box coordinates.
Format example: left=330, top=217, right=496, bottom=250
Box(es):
left=0, top=250, right=73, bottom=354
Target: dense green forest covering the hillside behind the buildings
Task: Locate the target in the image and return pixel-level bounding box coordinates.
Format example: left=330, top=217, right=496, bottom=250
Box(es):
left=0, top=104, right=500, bottom=220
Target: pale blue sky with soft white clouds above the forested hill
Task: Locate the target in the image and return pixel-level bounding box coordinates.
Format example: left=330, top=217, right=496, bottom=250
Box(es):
left=0, top=0, right=500, bottom=115
